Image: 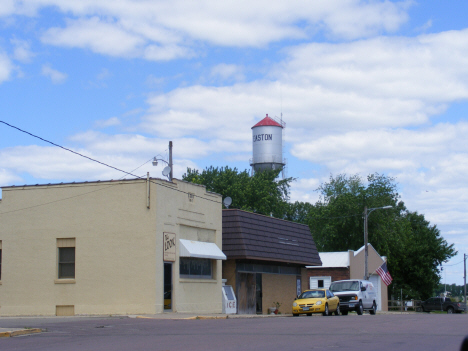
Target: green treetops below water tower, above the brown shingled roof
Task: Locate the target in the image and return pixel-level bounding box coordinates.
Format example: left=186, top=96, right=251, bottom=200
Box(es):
left=182, top=166, right=294, bottom=218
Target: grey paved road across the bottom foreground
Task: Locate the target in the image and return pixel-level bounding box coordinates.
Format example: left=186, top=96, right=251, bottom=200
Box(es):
left=0, top=313, right=468, bottom=351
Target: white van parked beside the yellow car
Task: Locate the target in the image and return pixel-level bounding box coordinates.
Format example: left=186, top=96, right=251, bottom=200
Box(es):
left=330, top=279, right=377, bottom=315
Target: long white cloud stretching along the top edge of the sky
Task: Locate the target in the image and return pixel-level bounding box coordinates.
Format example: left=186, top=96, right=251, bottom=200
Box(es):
left=0, top=0, right=411, bottom=60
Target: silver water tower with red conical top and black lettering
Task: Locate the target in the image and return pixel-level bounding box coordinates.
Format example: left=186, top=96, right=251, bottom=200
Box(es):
left=250, top=114, right=286, bottom=177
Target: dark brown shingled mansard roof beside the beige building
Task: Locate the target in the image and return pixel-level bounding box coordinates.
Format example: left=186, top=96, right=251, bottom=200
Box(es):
left=223, top=209, right=322, bottom=266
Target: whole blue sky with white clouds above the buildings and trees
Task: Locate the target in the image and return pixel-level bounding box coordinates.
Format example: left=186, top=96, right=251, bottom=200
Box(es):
left=0, top=0, right=468, bottom=285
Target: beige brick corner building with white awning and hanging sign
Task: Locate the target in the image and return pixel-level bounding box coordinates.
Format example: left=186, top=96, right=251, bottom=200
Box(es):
left=0, top=178, right=225, bottom=316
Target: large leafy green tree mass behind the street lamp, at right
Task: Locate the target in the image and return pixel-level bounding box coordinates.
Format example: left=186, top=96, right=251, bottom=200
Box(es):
left=306, top=173, right=456, bottom=299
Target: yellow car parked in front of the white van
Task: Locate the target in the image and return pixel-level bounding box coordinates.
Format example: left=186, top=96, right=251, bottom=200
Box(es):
left=292, top=289, right=340, bottom=317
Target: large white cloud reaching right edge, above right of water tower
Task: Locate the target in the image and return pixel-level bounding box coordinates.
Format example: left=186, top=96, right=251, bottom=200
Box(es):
left=276, top=30, right=468, bottom=104
